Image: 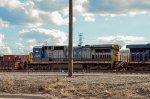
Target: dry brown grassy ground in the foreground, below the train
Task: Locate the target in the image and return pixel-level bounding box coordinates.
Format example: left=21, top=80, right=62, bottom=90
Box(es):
left=0, top=73, right=150, bottom=99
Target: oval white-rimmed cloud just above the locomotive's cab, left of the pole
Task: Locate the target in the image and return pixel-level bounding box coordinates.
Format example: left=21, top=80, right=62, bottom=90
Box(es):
left=19, top=28, right=67, bottom=44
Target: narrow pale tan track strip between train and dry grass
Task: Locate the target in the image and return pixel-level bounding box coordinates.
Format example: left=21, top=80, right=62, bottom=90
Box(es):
left=0, top=72, right=150, bottom=78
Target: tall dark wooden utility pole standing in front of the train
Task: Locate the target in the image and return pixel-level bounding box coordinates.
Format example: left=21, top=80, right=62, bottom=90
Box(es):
left=68, top=0, right=73, bottom=77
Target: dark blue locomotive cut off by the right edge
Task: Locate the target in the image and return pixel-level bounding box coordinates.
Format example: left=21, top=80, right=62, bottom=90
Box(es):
left=126, top=44, right=150, bottom=71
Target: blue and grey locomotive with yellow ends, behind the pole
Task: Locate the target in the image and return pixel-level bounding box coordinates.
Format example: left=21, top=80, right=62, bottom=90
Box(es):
left=24, top=44, right=120, bottom=71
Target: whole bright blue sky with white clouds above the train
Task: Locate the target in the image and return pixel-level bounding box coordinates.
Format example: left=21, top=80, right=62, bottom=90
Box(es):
left=0, top=0, right=150, bottom=54
